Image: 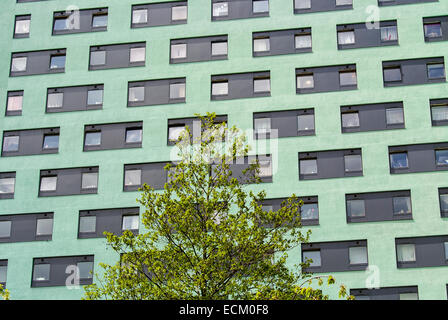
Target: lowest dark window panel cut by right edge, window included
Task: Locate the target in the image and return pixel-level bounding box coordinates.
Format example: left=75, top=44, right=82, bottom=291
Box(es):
left=395, top=235, right=448, bottom=269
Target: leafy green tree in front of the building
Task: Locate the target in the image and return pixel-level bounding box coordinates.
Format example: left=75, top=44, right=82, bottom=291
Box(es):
left=84, top=114, right=346, bottom=300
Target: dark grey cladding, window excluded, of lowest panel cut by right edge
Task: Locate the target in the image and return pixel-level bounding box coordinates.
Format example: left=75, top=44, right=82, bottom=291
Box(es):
left=395, top=235, right=448, bottom=268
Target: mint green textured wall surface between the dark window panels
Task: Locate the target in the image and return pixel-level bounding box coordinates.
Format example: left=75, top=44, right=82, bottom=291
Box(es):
left=0, top=0, right=448, bottom=299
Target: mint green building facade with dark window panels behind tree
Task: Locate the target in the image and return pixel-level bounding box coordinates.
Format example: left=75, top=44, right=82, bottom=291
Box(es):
left=0, top=0, right=448, bottom=299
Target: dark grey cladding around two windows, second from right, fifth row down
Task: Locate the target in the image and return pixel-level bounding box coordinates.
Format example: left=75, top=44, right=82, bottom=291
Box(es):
left=299, top=149, right=363, bottom=180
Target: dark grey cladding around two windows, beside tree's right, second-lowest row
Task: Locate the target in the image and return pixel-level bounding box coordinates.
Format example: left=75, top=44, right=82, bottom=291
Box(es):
left=302, top=240, right=368, bottom=272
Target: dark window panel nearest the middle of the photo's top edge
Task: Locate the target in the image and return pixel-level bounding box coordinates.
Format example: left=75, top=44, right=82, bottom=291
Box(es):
left=212, top=0, right=269, bottom=21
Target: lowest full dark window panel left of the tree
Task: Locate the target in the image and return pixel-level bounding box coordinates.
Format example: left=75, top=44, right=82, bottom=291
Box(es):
left=31, top=255, right=94, bottom=288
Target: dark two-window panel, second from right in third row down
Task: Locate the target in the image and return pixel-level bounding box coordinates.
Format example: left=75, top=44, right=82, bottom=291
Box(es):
left=296, top=64, right=358, bottom=94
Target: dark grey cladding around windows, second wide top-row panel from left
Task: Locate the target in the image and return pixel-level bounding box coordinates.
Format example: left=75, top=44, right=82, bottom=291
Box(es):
left=131, top=1, right=188, bottom=28
